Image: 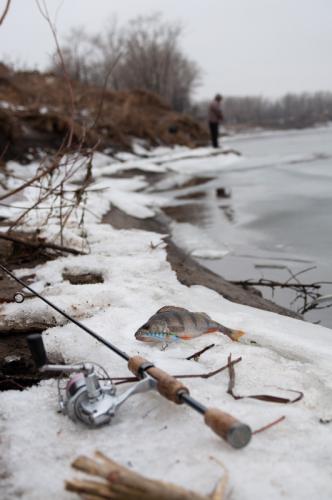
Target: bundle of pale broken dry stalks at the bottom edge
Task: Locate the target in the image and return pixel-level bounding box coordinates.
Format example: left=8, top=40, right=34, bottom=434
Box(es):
left=65, top=452, right=227, bottom=500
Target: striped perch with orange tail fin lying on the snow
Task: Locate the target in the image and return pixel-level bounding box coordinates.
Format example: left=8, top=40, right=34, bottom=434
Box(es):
left=135, top=306, right=244, bottom=345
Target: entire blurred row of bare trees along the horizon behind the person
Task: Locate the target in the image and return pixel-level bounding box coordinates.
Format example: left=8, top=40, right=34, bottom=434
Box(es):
left=49, top=14, right=332, bottom=128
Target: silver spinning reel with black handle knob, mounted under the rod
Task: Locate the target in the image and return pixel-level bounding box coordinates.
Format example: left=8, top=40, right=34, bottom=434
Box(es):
left=28, top=334, right=156, bottom=427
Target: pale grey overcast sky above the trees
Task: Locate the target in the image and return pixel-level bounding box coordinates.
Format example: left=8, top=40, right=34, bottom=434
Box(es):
left=0, top=0, right=332, bottom=98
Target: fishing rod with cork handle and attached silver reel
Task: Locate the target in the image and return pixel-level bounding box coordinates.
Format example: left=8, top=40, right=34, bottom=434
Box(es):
left=0, top=264, right=252, bottom=448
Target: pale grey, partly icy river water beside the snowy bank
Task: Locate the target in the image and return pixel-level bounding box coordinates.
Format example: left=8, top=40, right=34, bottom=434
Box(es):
left=171, top=126, right=332, bottom=327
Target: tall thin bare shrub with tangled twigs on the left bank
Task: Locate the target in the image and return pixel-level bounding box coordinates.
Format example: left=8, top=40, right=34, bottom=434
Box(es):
left=0, top=0, right=99, bottom=248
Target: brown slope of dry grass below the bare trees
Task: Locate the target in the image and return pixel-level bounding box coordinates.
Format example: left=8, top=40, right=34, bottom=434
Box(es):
left=0, top=64, right=208, bottom=158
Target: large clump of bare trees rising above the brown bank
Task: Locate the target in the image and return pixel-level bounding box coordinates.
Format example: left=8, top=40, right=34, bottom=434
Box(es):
left=52, top=14, right=200, bottom=111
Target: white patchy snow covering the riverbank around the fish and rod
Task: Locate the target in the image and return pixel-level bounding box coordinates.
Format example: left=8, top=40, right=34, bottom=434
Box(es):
left=0, top=143, right=332, bottom=500
